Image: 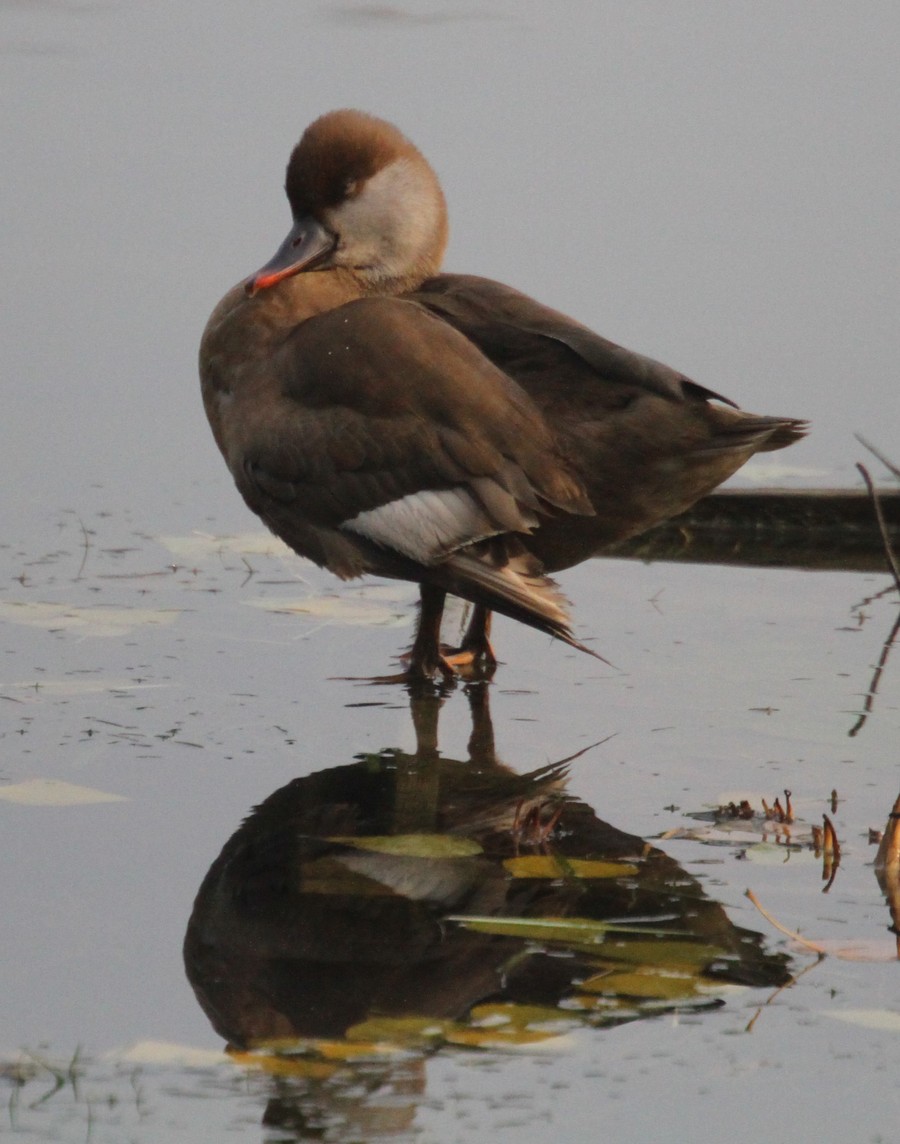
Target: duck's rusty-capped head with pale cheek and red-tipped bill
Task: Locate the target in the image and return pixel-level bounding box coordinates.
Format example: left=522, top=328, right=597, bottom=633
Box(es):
left=246, top=110, right=447, bottom=294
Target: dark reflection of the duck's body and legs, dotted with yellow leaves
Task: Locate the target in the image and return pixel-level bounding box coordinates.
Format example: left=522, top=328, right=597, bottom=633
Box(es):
left=185, top=686, right=787, bottom=1051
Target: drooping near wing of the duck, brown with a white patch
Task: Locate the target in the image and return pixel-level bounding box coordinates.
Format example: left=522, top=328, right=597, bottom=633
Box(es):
left=206, top=297, right=594, bottom=638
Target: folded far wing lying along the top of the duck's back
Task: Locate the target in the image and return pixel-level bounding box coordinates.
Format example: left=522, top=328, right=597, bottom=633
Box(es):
left=409, top=275, right=734, bottom=405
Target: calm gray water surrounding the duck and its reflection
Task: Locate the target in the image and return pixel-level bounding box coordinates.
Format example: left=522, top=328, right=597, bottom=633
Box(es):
left=0, top=0, right=900, bottom=1144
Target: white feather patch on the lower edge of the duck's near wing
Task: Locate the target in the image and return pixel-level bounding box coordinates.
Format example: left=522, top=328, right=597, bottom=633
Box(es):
left=341, top=488, right=502, bottom=564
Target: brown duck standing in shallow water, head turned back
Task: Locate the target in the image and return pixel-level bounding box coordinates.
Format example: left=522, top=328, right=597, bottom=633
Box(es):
left=199, top=109, right=806, bottom=681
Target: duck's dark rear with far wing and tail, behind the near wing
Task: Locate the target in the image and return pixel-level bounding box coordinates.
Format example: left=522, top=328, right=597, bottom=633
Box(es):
left=411, top=275, right=805, bottom=571
